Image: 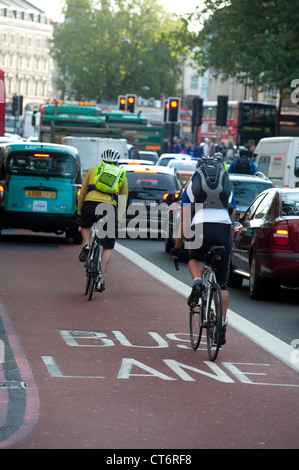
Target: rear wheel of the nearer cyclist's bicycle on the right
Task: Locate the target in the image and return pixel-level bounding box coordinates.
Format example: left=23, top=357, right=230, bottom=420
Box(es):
left=207, top=283, right=222, bottom=361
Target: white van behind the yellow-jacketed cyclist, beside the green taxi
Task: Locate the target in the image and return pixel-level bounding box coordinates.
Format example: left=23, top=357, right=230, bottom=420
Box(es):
left=61, top=136, right=129, bottom=176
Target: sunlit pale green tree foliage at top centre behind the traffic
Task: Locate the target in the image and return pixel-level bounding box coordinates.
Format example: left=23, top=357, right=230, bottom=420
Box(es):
left=52, top=0, right=180, bottom=100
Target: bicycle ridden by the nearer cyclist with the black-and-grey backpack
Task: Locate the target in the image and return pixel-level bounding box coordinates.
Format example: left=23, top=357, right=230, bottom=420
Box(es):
left=174, top=245, right=225, bottom=361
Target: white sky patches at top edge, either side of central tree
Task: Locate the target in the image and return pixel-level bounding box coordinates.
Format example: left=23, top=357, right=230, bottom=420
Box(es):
left=29, top=0, right=201, bottom=20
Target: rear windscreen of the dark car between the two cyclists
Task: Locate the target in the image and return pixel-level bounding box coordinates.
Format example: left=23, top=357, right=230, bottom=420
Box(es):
left=126, top=171, right=181, bottom=191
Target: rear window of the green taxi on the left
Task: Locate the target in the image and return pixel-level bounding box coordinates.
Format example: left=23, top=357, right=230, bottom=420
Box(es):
left=7, top=150, right=76, bottom=178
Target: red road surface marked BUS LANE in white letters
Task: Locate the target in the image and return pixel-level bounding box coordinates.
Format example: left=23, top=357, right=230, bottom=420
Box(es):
left=0, top=233, right=299, bottom=450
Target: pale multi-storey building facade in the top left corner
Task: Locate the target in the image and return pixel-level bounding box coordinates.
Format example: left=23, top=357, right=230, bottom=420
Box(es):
left=0, top=0, right=53, bottom=110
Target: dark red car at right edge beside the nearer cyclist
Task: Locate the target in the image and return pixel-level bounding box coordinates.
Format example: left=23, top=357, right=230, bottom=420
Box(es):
left=228, top=188, right=299, bottom=299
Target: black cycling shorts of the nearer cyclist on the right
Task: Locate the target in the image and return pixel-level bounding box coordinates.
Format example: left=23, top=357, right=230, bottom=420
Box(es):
left=189, top=222, right=232, bottom=290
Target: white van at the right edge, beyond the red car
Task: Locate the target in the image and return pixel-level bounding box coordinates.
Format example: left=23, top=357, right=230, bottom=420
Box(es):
left=255, top=137, right=299, bottom=188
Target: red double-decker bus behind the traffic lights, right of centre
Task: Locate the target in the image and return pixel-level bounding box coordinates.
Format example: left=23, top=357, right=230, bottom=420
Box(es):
left=197, top=101, right=278, bottom=145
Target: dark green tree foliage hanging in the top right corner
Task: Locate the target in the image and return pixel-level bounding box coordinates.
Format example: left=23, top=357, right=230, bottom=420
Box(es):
left=177, top=0, right=299, bottom=97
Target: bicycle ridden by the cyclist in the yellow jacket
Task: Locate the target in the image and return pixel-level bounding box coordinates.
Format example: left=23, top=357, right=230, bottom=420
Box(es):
left=85, top=217, right=107, bottom=300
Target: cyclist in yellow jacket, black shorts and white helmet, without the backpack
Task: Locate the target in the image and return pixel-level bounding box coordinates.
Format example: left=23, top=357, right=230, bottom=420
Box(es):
left=78, top=149, right=128, bottom=291
